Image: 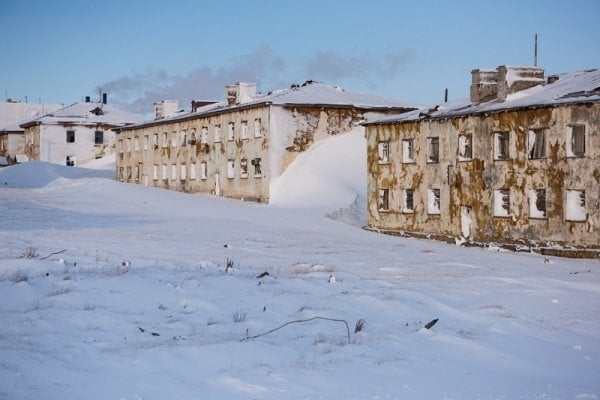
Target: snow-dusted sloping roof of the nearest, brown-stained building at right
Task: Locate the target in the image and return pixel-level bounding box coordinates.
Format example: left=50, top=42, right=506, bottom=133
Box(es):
left=365, top=69, right=600, bottom=125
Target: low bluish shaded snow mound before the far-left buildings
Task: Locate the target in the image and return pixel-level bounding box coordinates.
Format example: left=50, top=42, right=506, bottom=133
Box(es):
left=0, top=161, right=114, bottom=189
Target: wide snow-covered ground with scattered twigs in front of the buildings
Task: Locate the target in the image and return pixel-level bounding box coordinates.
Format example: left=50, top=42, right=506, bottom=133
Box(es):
left=0, top=162, right=600, bottom=400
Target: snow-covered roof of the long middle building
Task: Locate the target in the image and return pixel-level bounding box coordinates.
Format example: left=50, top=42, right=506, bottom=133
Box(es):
left=126, top=81, right=416, bottom=126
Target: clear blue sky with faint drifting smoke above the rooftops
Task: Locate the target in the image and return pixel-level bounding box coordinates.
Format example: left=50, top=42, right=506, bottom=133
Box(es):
left=0, top=0, right=600, bottom=112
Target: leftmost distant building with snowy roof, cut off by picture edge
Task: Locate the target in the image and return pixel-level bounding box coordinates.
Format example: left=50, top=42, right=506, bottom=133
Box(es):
left=0, top=99, right=63, bottom=165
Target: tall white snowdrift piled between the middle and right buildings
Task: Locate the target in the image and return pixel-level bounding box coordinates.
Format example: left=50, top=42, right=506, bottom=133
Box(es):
left=269, top=127, right=367, bottom=210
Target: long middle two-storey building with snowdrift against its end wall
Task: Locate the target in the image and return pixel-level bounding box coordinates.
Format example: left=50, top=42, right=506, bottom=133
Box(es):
left=116, top=81, right=415, bottom=202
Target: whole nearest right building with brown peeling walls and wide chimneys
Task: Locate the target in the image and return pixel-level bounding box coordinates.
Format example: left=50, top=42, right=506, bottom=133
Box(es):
left=365, top=66, right=600, bottom=253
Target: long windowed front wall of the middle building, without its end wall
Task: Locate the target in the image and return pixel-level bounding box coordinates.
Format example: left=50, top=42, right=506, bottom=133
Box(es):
left=116, top=106, right=269, bottom=202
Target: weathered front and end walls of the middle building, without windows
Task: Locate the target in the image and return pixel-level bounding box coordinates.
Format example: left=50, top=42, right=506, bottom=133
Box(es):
left=116, top=105, right=404, bottom=202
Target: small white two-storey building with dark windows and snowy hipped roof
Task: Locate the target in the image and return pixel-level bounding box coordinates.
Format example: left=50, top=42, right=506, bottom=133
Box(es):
left=20, top=93, right=142, bottom=166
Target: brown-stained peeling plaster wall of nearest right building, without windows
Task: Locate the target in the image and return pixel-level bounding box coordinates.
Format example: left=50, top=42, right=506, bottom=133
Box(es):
left=367, top=104, right=600, bottom=248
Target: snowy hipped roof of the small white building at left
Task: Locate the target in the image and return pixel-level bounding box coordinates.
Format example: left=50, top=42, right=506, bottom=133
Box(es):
left=21, top=102, right=143, bottom=127
